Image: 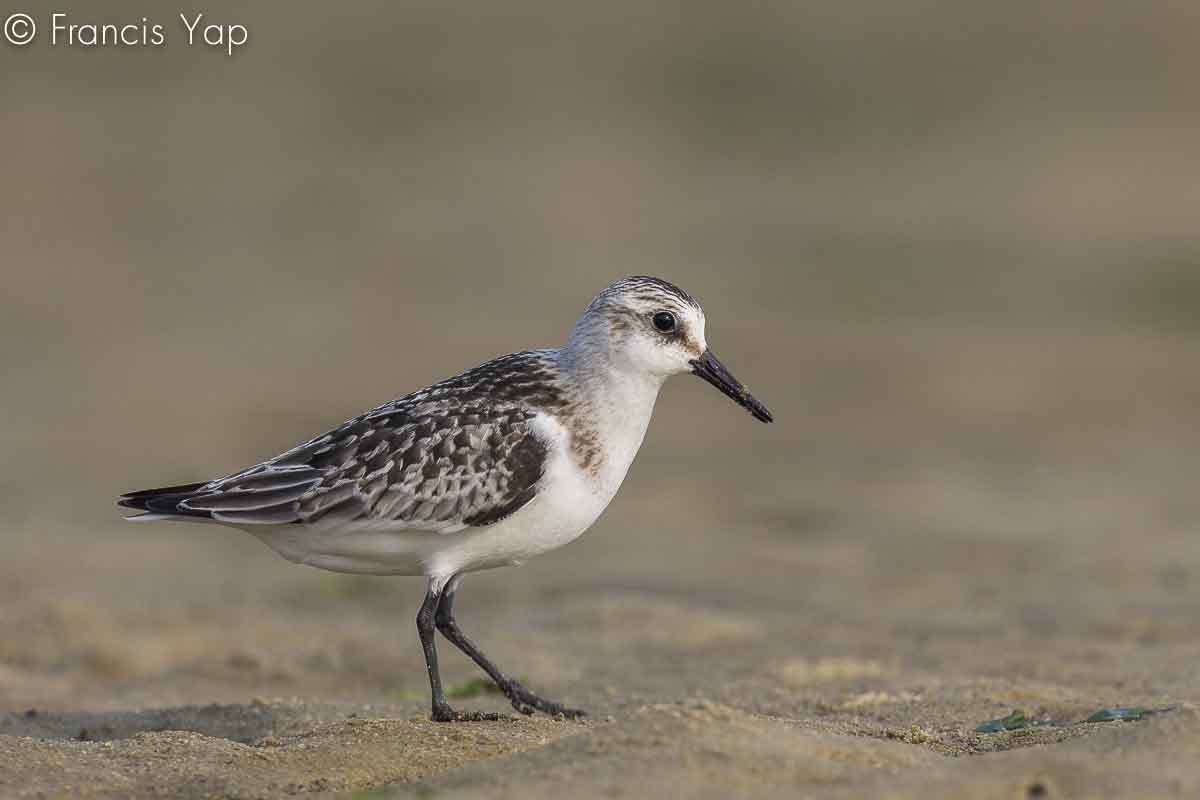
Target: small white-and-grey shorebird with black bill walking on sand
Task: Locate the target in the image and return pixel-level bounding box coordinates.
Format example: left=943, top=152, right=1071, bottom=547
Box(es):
left=118, top=276, right=772, bottom=722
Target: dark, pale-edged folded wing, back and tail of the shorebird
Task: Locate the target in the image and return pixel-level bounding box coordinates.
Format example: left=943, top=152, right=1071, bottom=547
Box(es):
left=120, top=350, right=563, bottom=533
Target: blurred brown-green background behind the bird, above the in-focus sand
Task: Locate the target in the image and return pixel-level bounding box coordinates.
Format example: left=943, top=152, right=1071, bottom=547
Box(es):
left=0, top=0, right=1200, bottom=777
